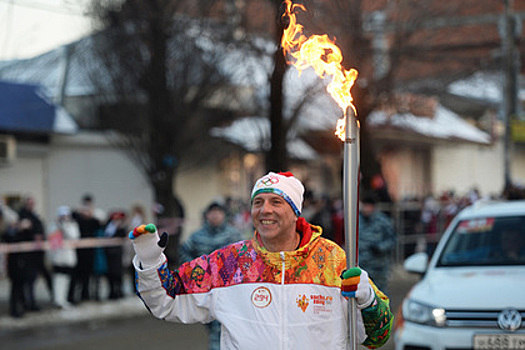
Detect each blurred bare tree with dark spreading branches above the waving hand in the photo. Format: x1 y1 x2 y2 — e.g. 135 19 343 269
87 0 239 217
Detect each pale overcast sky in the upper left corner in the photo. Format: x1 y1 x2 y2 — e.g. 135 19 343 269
0 0 91 60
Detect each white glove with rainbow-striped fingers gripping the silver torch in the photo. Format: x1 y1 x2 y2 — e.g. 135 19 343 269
341 267 376 309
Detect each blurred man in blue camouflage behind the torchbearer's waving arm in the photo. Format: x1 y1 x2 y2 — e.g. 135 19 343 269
179 202 242 350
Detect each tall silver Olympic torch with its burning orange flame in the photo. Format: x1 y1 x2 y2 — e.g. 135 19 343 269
281 0 359 350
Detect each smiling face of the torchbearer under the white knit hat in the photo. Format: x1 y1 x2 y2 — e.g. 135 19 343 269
251 193 297 243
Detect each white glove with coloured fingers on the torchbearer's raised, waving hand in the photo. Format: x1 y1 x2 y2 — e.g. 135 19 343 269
129 224 168 269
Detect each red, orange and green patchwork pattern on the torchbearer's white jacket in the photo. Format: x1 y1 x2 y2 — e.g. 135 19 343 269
149 219 393 348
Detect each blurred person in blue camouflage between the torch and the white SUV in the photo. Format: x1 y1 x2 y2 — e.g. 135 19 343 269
359 193 396 292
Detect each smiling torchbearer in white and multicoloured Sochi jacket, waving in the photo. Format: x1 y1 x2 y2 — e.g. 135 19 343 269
130 173 393 350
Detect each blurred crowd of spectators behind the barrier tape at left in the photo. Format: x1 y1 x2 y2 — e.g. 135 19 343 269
0 194 145 318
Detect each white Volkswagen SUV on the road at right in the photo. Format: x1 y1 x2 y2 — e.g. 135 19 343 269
395 201 525 350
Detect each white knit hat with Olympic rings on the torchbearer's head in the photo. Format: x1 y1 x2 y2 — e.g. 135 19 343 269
252 171 304 216
